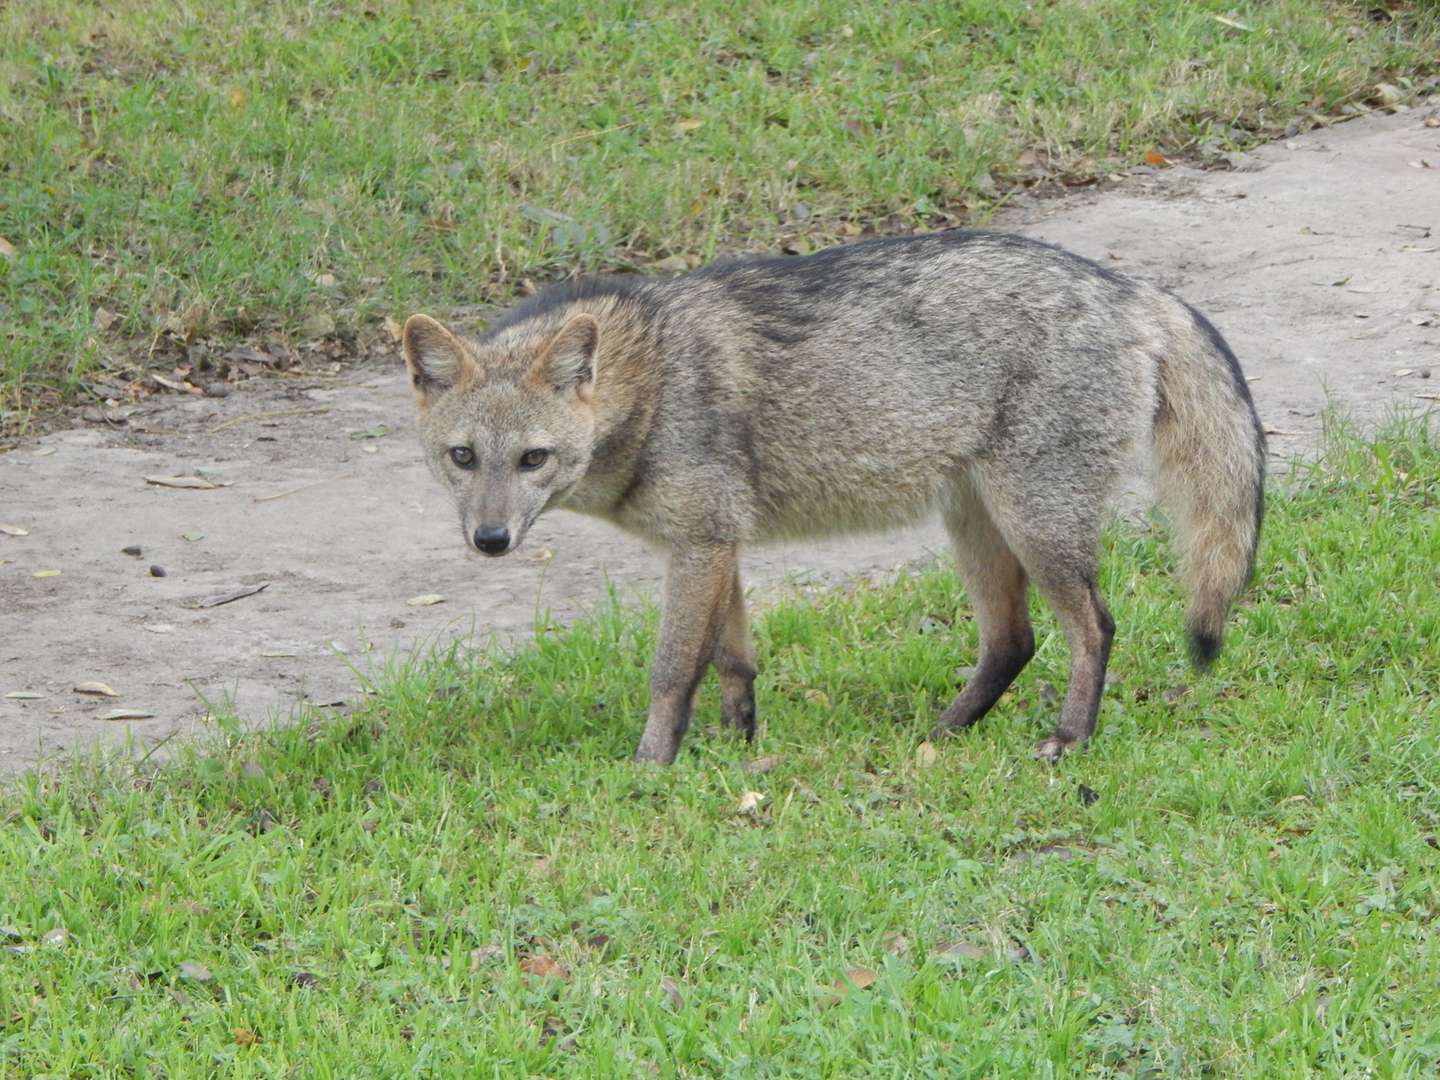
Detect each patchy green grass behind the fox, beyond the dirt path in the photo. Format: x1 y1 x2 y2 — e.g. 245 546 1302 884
0 0 1440 433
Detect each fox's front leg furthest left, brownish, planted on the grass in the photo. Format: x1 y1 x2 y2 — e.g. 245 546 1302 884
635 544 737 765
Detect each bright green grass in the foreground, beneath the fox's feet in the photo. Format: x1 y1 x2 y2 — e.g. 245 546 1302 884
0 423 1440 1080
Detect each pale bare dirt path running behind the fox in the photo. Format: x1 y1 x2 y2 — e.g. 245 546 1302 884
0 109 1440 769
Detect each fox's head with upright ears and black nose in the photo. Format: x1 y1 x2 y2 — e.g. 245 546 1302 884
402 314 600 556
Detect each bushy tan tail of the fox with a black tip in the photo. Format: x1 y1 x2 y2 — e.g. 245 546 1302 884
1155 310 1266 668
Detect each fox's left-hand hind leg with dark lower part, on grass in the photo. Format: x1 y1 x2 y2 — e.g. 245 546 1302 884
935 480 1035 737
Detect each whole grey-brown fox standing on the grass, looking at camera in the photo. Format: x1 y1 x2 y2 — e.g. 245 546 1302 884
405 232 1264 762
